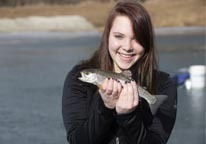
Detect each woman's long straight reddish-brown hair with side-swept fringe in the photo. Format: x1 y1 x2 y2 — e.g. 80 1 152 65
80 0 157 93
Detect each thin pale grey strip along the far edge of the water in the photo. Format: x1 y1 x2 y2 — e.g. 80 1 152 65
0 26 203 37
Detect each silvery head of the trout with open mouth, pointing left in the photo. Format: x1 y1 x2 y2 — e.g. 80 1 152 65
79 69 97 84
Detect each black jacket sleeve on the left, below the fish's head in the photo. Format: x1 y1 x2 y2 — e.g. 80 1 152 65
62 66 114 144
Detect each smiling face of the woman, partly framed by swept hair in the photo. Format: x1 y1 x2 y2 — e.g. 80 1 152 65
109 16 144 72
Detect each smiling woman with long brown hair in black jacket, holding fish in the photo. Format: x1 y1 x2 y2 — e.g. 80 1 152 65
62 0 177 144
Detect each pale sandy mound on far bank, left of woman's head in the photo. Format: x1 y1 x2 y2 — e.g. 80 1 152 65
0 15 95 32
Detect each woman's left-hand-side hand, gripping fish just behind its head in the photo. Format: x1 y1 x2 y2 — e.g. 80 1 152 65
99 78 122 109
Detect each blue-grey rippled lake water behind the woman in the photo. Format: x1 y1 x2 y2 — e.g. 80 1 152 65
0 32 205 144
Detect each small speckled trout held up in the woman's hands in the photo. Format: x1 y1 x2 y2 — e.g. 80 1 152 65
78 69 167 114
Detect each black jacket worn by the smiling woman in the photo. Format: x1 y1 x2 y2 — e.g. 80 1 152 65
62 66 177 144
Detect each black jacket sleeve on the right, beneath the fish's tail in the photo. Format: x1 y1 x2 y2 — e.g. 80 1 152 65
116 75 177 144
